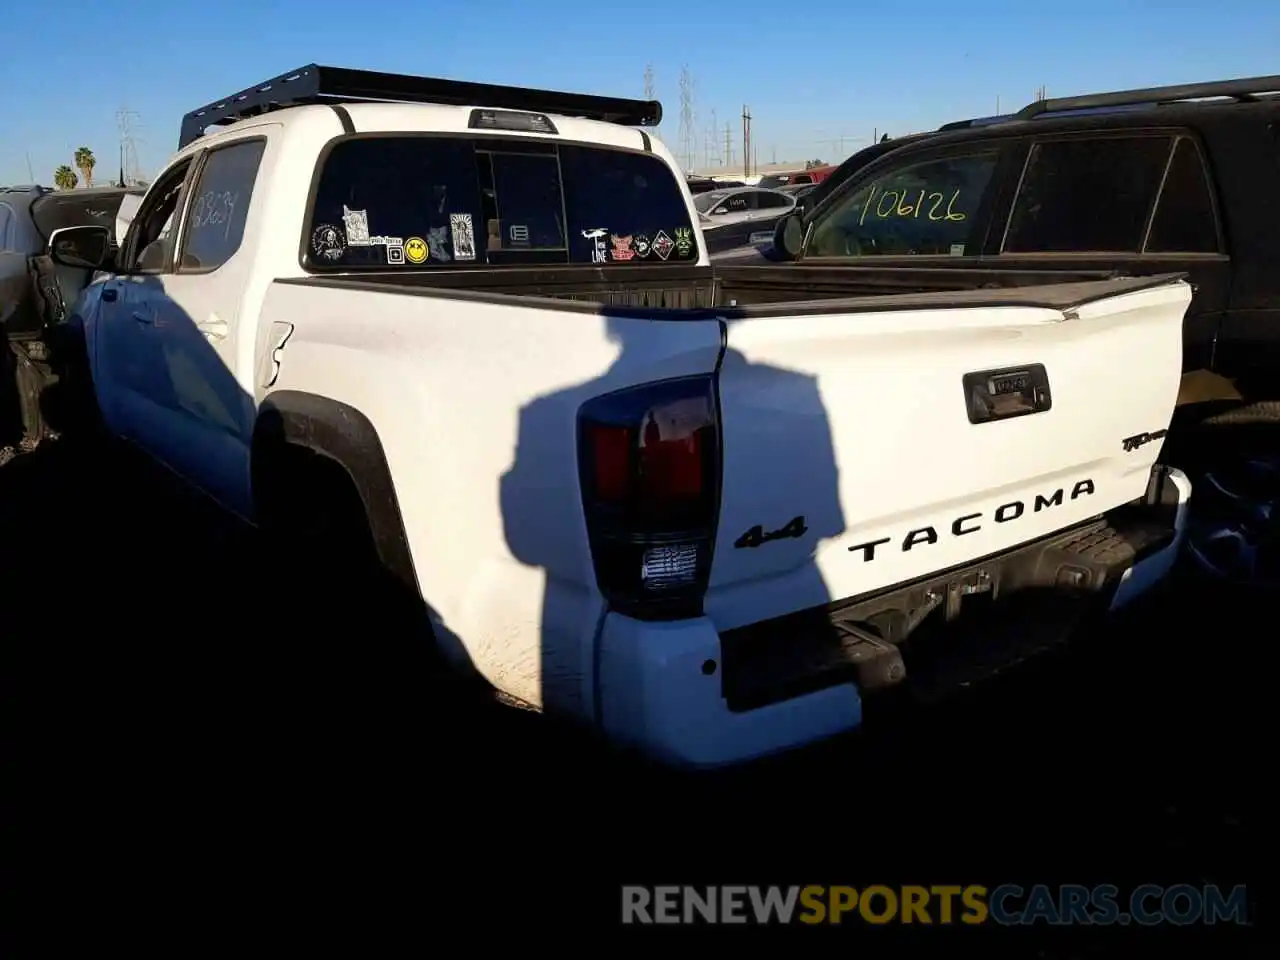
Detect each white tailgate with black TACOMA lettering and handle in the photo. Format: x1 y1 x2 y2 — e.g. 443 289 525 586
705 276 1192 630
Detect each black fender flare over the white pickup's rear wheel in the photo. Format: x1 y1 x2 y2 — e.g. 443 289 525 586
250 390 419 594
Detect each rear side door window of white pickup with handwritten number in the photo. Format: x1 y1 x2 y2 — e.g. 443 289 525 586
178 140 266 273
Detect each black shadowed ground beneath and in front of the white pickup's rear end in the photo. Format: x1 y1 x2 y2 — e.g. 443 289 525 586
0 442 1259 956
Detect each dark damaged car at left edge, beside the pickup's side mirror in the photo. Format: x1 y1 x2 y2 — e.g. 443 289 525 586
0 184 143 448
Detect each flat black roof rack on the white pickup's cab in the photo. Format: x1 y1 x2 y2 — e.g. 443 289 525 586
178 64 662 150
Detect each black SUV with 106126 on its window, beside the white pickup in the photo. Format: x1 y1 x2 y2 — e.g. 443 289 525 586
757 77 1280 401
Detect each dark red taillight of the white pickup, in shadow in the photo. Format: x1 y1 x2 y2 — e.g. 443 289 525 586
579 376 719 620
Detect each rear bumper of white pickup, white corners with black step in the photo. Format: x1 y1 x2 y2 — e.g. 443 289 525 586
596 467 1190 767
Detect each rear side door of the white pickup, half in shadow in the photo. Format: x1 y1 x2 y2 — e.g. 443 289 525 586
133 136 266 516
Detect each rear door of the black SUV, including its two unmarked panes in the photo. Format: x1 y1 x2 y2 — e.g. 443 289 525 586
998 129 1231 371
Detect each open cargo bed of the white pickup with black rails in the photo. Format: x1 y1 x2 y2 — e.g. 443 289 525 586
280 265 1162 320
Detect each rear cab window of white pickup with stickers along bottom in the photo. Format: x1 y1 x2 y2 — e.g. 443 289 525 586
305 137 699 270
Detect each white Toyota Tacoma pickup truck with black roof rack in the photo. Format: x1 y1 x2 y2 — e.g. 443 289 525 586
51 65 1190 765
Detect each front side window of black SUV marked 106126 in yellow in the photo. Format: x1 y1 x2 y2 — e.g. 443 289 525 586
805 150 998 257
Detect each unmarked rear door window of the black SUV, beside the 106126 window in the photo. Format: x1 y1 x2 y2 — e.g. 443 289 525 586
1004 137 1171 253
